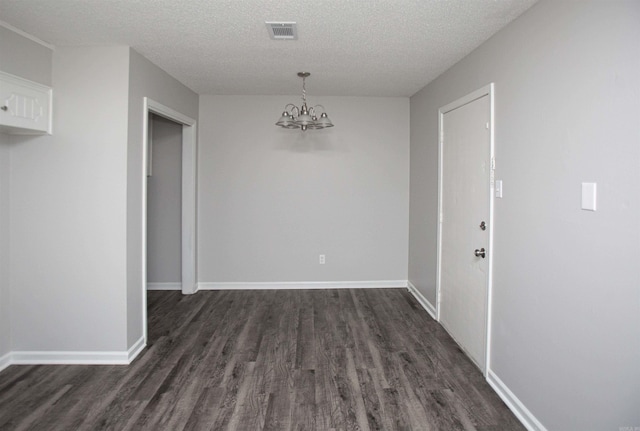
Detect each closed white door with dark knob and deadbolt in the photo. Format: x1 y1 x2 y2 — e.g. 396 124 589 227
439 93 492 371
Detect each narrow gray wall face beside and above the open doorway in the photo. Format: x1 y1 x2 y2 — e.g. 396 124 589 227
126 49 198 346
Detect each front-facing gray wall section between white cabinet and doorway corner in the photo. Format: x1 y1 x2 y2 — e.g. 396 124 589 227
10 47 129 351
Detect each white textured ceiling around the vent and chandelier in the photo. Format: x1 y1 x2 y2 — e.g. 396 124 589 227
0 0 536 96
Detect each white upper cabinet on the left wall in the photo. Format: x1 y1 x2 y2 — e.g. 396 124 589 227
0 71 52 135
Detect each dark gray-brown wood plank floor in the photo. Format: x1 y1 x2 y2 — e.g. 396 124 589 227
0 289 524 431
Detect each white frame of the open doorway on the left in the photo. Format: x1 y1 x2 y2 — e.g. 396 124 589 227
142 97 198 343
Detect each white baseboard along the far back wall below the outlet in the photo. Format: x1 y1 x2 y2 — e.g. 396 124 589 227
198 280 407 290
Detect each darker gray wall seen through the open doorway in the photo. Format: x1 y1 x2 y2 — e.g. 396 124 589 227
147 115 182 283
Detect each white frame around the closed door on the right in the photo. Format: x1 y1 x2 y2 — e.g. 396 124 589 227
436 83 495 377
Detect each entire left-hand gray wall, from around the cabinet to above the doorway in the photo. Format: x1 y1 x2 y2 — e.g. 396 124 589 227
0 27 198 355
